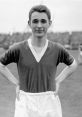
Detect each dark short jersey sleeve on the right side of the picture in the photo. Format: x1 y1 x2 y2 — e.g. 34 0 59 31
57 45 74 65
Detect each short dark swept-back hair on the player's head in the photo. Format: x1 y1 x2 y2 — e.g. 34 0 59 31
29 5 51 20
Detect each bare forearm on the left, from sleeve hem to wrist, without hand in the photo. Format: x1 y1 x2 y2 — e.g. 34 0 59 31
0 63 19 86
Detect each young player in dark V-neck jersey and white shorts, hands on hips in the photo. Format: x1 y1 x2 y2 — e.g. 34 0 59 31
0 5 77 117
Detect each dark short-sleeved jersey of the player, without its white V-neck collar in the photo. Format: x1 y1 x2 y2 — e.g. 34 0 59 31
0 40 74 93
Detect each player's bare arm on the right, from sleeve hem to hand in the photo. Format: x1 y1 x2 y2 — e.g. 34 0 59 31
56 59 77 92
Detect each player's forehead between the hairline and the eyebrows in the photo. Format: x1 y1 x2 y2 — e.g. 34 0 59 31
31 12 48 20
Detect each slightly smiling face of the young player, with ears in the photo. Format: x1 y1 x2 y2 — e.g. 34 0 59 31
29 12 51 37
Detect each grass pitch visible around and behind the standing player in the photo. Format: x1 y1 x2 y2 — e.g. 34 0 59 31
0 50 82 117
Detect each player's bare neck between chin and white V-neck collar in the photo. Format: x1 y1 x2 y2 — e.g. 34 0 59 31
31 35 47 47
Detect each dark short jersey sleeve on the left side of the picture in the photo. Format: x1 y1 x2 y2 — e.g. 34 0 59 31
0 44 20 65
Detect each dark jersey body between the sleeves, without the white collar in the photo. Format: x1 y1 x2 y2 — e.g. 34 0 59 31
18 39 58 92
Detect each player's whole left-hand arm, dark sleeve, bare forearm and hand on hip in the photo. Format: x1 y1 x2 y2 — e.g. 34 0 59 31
0 44 20 99
